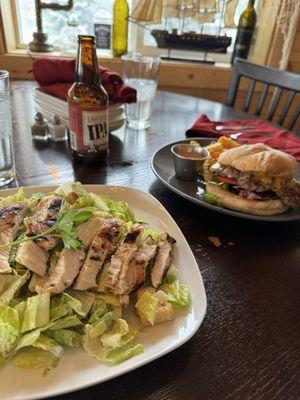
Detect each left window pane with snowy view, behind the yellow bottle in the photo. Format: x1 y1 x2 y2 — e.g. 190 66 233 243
15 0 132 52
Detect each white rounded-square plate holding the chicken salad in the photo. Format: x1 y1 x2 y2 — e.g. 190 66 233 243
0 185 206 400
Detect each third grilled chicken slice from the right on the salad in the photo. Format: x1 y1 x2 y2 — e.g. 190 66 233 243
106 224 144 294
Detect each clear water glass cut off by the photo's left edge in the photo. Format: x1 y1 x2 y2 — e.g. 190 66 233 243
0 70 15 186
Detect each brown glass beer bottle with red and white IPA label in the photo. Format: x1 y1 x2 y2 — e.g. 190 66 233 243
67 35 109 161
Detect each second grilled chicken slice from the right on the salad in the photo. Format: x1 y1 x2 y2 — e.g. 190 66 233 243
127 237 157 293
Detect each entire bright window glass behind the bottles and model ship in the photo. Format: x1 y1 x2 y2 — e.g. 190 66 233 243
14 0 254 62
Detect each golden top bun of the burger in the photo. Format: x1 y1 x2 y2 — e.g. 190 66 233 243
218 143 297 179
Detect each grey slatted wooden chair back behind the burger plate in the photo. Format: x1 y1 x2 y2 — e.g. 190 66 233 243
225 58 300 129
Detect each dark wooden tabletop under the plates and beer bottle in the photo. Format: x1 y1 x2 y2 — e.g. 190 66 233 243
7 82 300 400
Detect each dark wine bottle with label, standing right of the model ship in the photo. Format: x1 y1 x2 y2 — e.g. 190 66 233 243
231 0 256 64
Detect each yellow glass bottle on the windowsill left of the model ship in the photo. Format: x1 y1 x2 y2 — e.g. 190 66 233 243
113 0 129 57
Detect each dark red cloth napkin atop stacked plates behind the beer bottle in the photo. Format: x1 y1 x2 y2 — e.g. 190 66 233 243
30 57 136 103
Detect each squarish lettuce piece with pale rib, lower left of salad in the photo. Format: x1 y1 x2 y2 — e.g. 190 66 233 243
15 292 50 333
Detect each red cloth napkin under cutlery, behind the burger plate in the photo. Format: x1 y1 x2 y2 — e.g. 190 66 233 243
186 114 300 161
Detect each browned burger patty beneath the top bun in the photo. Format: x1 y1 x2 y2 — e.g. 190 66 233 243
219 167 300 208
